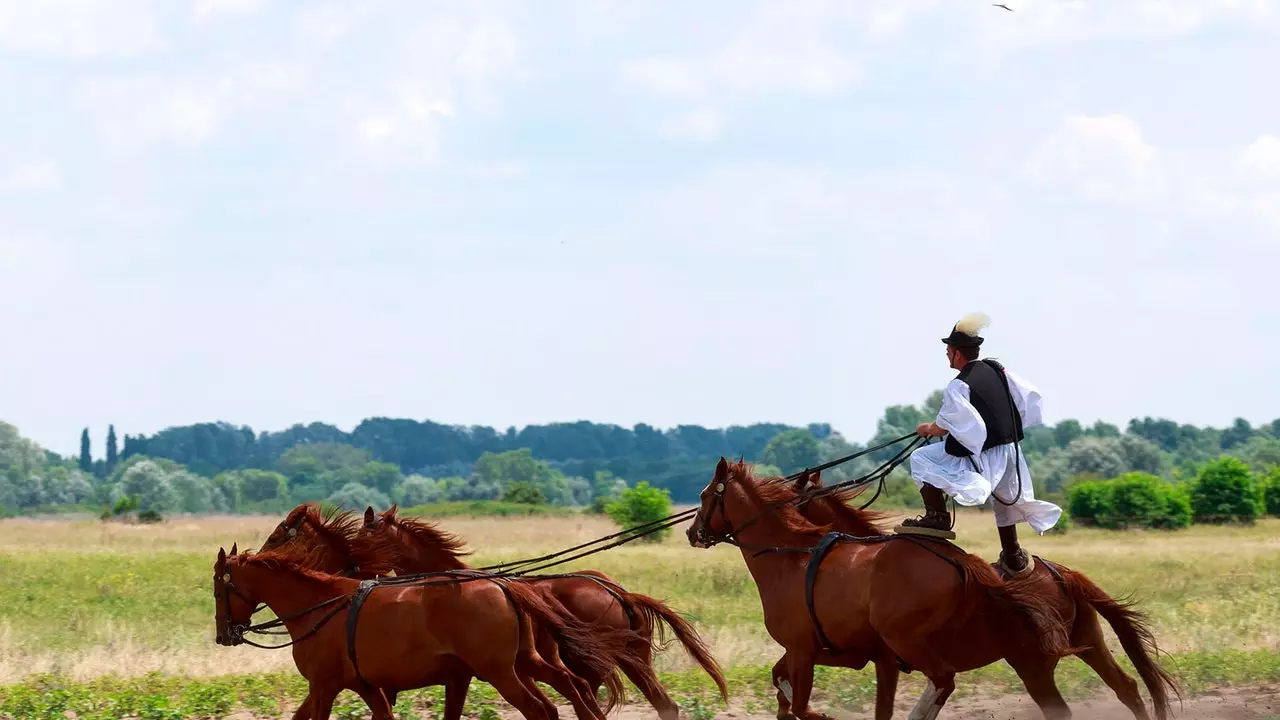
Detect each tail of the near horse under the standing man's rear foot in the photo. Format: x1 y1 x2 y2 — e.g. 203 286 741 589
956 553 1076 659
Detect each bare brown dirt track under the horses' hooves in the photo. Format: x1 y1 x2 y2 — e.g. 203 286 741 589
222 685 1280 720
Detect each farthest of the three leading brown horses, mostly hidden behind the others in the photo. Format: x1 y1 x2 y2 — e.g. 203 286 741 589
365 505 728 720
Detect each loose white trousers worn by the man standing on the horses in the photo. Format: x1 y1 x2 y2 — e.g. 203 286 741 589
911 442 1062 534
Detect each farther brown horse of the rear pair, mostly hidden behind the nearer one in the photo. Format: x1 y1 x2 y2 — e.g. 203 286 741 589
774 473 1180 720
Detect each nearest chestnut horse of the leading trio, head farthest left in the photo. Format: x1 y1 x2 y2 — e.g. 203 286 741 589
225 520 628 720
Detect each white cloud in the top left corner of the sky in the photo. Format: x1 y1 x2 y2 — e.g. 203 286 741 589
0 0 165 59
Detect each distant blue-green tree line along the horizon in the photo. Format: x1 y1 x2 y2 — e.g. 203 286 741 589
0 392 1280 514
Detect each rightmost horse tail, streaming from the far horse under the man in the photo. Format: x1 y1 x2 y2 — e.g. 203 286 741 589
1056 565 1183 720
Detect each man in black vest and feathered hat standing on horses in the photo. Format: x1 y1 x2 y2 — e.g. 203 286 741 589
897 314 1062 575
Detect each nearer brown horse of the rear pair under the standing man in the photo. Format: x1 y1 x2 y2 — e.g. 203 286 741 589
687 457 1073 720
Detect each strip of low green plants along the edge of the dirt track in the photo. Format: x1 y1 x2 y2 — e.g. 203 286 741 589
0 652 1280 720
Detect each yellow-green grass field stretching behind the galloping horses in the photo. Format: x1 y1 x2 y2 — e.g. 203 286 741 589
0 511 1280 717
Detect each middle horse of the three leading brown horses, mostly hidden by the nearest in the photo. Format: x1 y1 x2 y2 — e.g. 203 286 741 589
250 503 630 720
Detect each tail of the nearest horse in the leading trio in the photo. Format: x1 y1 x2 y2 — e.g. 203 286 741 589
503 573 637 715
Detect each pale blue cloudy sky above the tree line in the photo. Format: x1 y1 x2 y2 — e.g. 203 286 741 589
0 0 1280 452
